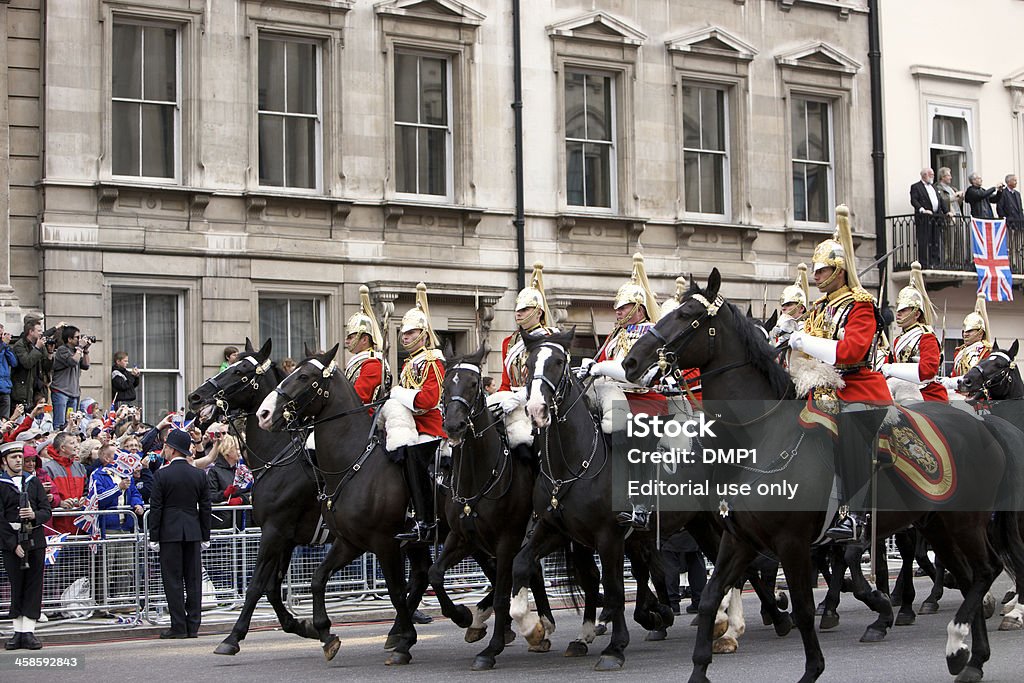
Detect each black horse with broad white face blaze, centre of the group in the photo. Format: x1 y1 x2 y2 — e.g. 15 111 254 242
511 332 673 671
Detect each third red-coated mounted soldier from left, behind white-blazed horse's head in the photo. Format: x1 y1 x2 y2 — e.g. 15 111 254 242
487 261 558 461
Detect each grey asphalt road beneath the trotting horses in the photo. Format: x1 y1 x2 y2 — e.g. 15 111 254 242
0 577 1024 683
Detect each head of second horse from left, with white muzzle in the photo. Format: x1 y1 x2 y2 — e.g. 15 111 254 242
256 344 339 431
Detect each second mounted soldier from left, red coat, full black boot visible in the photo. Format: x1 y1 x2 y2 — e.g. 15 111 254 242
381 283 446 543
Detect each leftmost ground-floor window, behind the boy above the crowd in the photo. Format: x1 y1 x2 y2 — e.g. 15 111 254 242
111 289 184 421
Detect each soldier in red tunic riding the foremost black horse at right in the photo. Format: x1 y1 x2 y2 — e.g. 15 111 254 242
790 206 892 541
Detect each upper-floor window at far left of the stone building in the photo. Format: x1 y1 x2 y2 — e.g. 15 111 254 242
111 23 181 178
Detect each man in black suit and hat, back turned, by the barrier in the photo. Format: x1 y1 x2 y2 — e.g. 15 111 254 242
150 429 210 638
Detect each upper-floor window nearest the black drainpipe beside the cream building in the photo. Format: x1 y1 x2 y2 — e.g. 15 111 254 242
793 97 834 223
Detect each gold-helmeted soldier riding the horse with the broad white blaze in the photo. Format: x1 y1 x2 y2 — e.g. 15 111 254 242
580 254 669 528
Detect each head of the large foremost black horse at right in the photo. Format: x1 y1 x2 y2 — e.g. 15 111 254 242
623 268 724 386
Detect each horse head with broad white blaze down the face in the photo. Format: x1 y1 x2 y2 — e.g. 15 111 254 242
523 328 575 429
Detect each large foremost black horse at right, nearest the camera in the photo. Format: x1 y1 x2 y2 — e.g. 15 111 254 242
623 269 1020 682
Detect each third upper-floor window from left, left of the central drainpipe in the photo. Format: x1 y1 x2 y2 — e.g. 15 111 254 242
394 52 452 197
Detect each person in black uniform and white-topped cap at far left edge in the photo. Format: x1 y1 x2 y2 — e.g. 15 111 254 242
0 441 50 650
